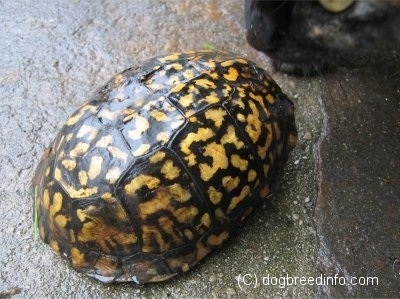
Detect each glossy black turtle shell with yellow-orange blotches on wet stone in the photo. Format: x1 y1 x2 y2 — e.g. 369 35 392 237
32 51 297 283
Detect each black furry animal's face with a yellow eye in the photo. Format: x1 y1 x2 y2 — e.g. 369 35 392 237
245 0 400 74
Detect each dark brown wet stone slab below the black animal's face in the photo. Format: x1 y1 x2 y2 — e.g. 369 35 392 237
315 55 400 297
